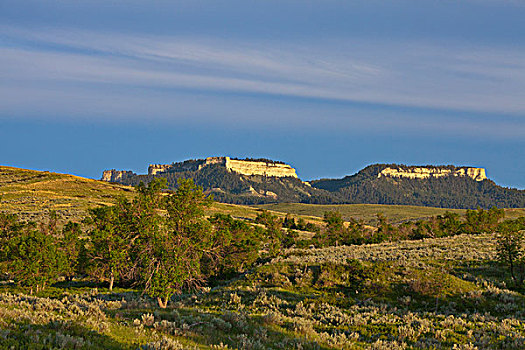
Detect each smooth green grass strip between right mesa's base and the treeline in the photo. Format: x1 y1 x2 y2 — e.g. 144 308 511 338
255 203 525 223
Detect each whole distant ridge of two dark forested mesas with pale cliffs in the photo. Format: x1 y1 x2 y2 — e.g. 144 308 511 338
102 157 525 209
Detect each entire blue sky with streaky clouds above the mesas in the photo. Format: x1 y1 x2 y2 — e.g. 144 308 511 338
0 0 525 189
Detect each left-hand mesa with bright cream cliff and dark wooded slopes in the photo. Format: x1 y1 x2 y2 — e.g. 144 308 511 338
102 157 330 204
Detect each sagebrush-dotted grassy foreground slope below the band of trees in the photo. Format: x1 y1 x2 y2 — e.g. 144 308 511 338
0 234 525 350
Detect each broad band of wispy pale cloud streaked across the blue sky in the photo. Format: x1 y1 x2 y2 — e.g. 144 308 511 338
0 26 525 134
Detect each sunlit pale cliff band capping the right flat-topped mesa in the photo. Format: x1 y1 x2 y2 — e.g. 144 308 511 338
377 166 487 181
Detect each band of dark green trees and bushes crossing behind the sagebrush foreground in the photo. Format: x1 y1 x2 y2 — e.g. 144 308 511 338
0 186 525 307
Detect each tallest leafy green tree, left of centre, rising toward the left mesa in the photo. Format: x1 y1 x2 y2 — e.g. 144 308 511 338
141 179 212 308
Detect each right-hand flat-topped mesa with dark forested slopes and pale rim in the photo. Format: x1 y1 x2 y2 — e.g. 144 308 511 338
311 164 525 209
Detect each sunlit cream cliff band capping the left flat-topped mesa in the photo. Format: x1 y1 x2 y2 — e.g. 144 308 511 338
148 157 297 178
